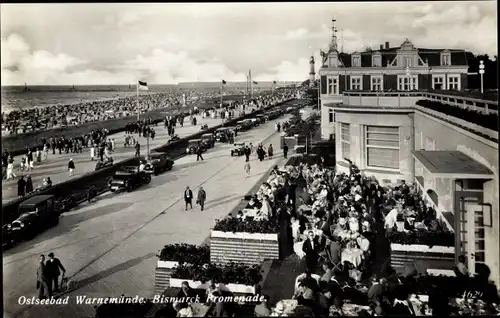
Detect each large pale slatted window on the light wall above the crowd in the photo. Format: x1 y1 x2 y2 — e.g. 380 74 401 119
365 126 399 169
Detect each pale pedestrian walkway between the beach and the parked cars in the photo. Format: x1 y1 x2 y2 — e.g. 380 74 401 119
2 116 221 204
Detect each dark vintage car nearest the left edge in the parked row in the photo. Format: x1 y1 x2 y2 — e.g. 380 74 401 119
10 195 61 241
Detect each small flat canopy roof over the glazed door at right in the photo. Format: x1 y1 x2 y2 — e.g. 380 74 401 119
413 150 493 179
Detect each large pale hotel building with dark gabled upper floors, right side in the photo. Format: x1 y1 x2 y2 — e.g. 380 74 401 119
319 19 500 286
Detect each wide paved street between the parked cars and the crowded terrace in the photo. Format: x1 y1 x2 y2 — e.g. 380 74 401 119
4 103 312 317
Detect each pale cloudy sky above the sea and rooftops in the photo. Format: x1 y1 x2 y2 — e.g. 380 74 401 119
0 1 497 85
